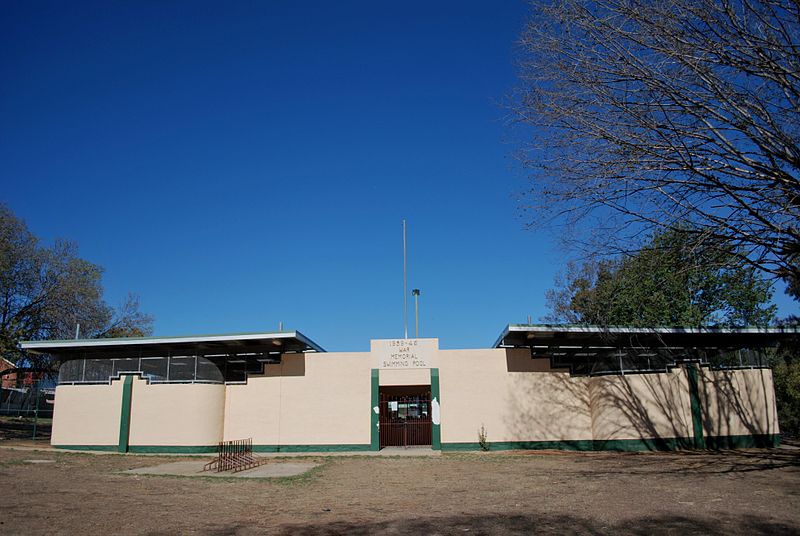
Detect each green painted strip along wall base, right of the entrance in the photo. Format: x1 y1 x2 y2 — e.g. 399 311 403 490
442 434 780 452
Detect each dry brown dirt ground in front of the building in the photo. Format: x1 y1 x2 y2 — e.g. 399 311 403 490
0 443 800 535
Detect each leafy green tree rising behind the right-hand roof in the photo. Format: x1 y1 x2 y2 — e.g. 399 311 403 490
546 227 775 327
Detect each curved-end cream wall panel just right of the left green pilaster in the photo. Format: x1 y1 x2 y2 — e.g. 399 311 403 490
128 377 225 446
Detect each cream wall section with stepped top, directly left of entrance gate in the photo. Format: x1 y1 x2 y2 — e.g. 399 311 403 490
225 353 371 445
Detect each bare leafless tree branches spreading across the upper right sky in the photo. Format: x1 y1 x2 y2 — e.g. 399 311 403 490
511 0 800 296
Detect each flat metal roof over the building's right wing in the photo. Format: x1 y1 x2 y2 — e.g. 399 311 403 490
494 324 800 348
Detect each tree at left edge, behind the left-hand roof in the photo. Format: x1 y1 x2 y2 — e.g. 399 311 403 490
0 205 153 374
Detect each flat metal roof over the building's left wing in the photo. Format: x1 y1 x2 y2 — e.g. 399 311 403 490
19 331 325 356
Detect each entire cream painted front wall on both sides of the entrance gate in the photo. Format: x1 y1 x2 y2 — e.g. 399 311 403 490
52 349 778 446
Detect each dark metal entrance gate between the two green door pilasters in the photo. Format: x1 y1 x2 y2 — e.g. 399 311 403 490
379 393 432 448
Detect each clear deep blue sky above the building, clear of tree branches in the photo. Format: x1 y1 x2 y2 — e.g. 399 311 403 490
0 0 795 350
